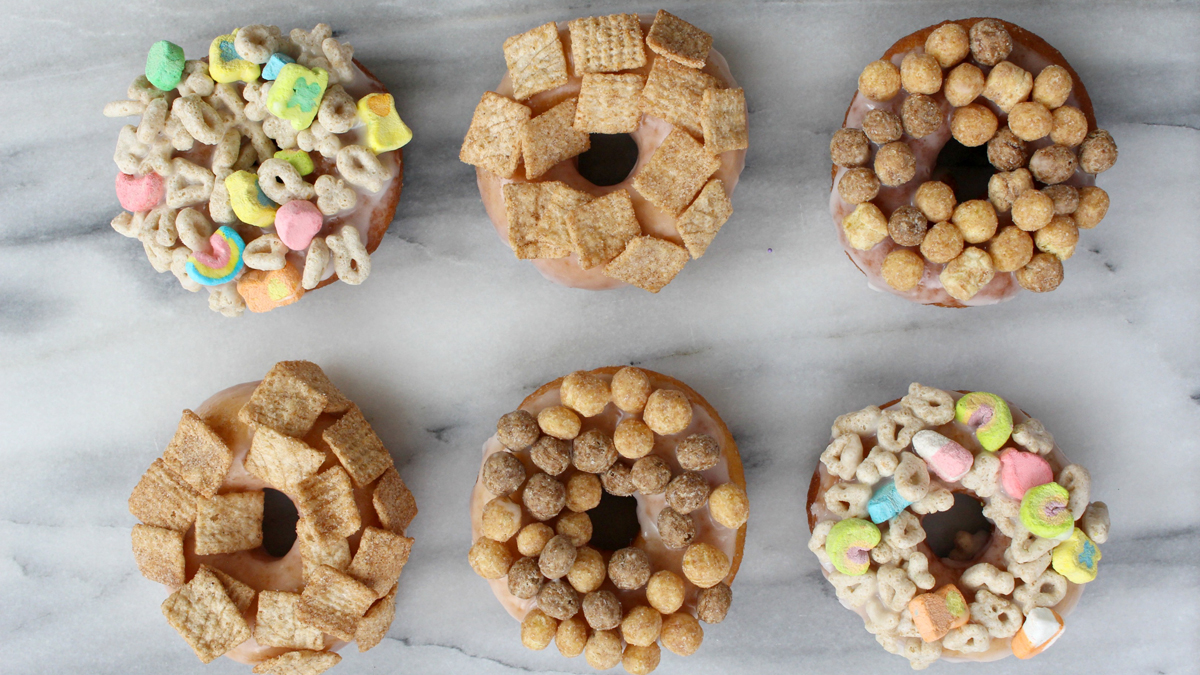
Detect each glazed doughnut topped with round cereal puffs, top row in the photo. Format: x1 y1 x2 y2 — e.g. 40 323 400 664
829 18 1117 307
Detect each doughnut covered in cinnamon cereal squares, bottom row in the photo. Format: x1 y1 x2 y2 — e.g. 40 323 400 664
130 362 416 674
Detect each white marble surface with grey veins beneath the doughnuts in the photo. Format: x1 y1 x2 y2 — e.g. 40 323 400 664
0 0 1200 675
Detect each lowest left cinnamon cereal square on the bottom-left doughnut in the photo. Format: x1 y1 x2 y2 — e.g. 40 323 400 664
162 562 250 663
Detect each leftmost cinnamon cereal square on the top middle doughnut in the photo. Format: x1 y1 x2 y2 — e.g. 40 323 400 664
458 91 533 178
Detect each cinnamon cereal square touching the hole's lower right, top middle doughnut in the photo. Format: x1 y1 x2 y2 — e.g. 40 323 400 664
632 129 721 215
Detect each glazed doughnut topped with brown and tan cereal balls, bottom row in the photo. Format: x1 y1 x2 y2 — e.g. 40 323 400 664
468 368 750 674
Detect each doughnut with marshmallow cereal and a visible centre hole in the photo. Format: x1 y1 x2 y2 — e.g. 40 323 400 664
806 383 1109 669
